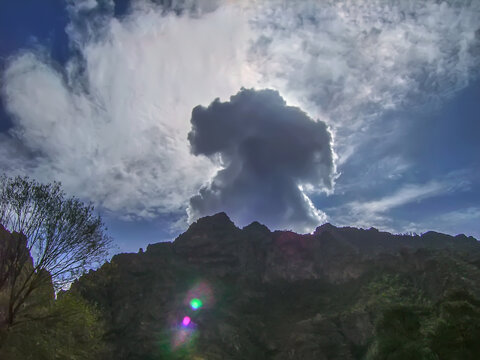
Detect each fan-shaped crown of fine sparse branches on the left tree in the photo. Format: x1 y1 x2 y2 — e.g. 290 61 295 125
0 176 111 290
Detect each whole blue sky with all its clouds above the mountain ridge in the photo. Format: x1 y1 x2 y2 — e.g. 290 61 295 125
0 0 480 252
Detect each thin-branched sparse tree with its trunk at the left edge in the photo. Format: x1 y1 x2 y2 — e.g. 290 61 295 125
0 176 111 327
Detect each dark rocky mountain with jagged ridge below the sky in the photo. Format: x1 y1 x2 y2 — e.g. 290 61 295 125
70 213 480 360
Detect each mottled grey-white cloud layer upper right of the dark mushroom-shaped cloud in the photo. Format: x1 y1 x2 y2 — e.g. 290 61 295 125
251 0 480 163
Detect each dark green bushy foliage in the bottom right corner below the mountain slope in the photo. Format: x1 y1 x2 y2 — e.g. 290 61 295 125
367 290 480 360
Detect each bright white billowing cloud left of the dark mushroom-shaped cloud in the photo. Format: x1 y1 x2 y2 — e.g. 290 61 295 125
0 2 258 218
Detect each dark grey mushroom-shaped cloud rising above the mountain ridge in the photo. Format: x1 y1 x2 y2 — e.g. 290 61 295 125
188 89 335 230
